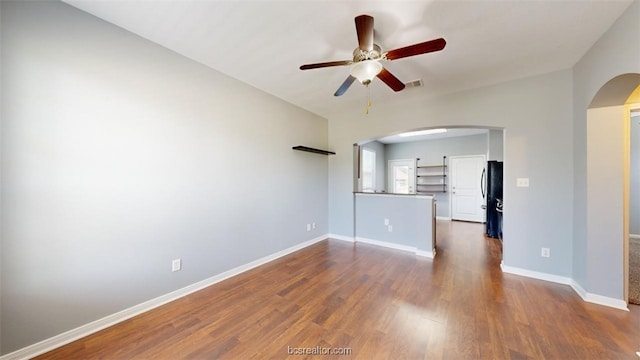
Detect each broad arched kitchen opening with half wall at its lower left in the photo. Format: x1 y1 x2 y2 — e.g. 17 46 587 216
353 126 506 257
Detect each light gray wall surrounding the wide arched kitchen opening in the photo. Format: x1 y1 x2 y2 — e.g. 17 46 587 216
329 70 573 282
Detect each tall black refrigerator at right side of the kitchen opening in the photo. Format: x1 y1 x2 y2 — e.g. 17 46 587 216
481 161 502 238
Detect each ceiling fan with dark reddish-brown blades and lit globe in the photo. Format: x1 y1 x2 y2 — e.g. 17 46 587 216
300 15 447 96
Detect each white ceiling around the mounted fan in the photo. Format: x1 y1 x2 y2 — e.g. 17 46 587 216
65 0 632 117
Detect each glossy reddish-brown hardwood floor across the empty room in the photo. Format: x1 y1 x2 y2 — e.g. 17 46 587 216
38 221 640 359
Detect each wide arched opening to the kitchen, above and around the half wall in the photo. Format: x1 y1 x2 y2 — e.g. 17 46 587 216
354 128 505 256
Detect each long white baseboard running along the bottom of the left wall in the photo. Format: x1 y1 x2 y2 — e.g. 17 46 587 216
0 235 329 360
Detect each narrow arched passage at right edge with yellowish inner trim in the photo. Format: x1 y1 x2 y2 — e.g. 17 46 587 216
586 74 640 307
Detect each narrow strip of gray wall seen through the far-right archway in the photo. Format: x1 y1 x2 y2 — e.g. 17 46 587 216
629 112 640 236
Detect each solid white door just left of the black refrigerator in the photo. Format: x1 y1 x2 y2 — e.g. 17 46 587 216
449 155 486 222
